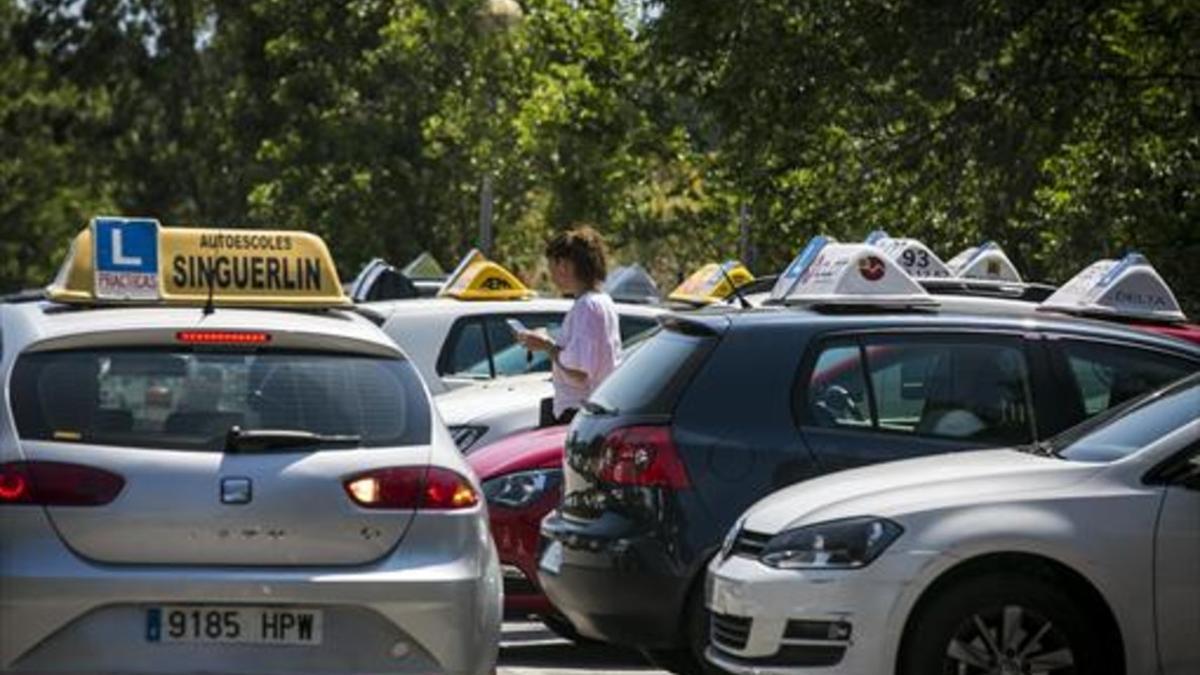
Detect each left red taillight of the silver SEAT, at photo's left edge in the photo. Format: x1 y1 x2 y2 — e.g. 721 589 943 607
0 461 125 506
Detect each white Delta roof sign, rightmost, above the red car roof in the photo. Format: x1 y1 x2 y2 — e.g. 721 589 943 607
1042 253 1187 323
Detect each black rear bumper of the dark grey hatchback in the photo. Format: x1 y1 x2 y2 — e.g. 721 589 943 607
538 513 692 649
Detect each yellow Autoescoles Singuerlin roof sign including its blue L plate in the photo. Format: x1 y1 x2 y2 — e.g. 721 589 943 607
47 217 350 307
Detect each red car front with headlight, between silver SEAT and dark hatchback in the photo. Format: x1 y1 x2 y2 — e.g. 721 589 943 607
467 426 578 640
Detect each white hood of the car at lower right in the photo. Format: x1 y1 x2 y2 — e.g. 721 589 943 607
743 449 1104 534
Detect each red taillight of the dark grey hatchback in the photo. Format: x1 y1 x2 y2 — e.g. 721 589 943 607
598 426 691 490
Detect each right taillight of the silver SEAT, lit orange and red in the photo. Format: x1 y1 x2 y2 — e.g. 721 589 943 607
343 466 479 510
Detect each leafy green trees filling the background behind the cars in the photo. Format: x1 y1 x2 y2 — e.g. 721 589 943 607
0 0 1200 315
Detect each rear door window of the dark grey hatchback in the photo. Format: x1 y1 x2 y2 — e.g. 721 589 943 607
865 338 1033 444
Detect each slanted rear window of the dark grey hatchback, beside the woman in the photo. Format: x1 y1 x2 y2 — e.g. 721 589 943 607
589 330 716 414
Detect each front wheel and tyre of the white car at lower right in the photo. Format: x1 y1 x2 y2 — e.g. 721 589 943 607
899 573 1121 675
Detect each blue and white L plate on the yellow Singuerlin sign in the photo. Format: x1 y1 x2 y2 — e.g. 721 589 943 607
91 217 158 299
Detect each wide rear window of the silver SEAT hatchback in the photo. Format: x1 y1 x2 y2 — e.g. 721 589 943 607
11 350 431 452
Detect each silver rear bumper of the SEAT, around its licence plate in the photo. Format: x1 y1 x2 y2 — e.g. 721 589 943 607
0 509 500 674
